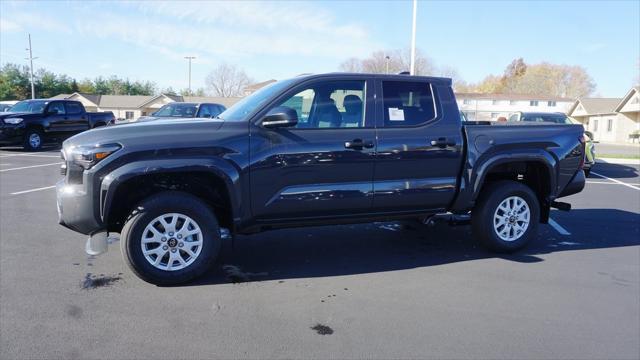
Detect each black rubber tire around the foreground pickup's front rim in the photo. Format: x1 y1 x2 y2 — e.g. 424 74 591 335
120 191 221 285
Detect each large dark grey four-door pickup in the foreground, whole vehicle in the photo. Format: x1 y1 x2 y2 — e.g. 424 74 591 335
57 73 585 284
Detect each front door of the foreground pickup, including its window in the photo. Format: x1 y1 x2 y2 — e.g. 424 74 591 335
250 77 375 219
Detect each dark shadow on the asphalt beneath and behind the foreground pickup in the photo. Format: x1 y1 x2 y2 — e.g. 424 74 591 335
186 209 640 286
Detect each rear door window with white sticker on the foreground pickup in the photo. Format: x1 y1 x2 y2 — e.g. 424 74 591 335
382 81 436 127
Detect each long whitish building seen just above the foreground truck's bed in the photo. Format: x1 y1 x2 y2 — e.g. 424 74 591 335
456 93 575 121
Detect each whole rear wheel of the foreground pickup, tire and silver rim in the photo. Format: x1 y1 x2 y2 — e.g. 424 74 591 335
471 181 540 252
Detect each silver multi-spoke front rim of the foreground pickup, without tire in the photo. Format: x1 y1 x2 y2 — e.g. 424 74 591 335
140 213 202 271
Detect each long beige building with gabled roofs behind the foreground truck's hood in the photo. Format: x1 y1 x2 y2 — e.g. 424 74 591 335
53 93 240 120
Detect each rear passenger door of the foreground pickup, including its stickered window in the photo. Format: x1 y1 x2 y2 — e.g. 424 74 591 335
373 78 463 212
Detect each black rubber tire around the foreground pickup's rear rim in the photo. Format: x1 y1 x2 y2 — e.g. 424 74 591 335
471 180 540 253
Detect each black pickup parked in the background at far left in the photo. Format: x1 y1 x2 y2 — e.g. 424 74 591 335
0 99 115 151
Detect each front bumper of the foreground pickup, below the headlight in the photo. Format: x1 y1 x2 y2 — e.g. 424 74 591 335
56 179 105 235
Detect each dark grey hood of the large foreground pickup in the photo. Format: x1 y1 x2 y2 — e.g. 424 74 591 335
63 119 229 149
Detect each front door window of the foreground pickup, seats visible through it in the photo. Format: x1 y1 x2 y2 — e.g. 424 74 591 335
276 81 365 129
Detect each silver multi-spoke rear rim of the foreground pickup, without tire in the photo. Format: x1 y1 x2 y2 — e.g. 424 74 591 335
493 196 531 241
